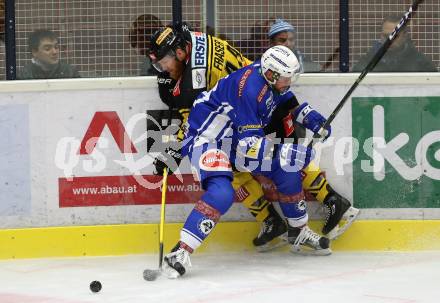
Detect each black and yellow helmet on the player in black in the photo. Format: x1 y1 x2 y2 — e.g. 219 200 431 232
150 26 186 62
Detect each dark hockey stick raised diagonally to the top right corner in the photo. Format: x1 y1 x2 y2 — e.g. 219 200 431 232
307 0 424 148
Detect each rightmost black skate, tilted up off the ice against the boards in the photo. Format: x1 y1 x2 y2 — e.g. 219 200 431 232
322 192 359 240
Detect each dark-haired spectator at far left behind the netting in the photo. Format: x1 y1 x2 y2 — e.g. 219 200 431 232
17 29 80 80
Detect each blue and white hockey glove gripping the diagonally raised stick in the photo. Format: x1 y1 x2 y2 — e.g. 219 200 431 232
294 102 332 141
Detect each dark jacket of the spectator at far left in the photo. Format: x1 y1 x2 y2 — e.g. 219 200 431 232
17 61 80 80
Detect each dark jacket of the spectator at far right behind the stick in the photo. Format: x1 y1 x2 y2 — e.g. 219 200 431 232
352 39 437 72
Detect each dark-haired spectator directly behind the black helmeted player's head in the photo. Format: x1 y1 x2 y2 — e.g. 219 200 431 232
128 14 163 76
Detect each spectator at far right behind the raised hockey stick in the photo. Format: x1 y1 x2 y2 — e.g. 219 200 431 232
352 16 437 72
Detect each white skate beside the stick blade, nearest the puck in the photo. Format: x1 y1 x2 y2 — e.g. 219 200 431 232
163 243 191 279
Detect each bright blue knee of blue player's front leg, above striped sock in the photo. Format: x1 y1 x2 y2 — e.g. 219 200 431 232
201 176 235 215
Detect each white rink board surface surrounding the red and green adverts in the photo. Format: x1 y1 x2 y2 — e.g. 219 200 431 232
0 75 440 228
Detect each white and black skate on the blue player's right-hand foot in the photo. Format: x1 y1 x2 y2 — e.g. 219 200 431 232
288 225 332 256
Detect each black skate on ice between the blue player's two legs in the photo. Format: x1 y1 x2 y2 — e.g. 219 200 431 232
253 210 288 252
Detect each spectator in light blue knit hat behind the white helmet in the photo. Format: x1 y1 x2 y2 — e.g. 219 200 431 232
268 19 321 73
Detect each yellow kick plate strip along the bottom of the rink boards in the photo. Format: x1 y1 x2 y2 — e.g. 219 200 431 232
0 220 440 259
